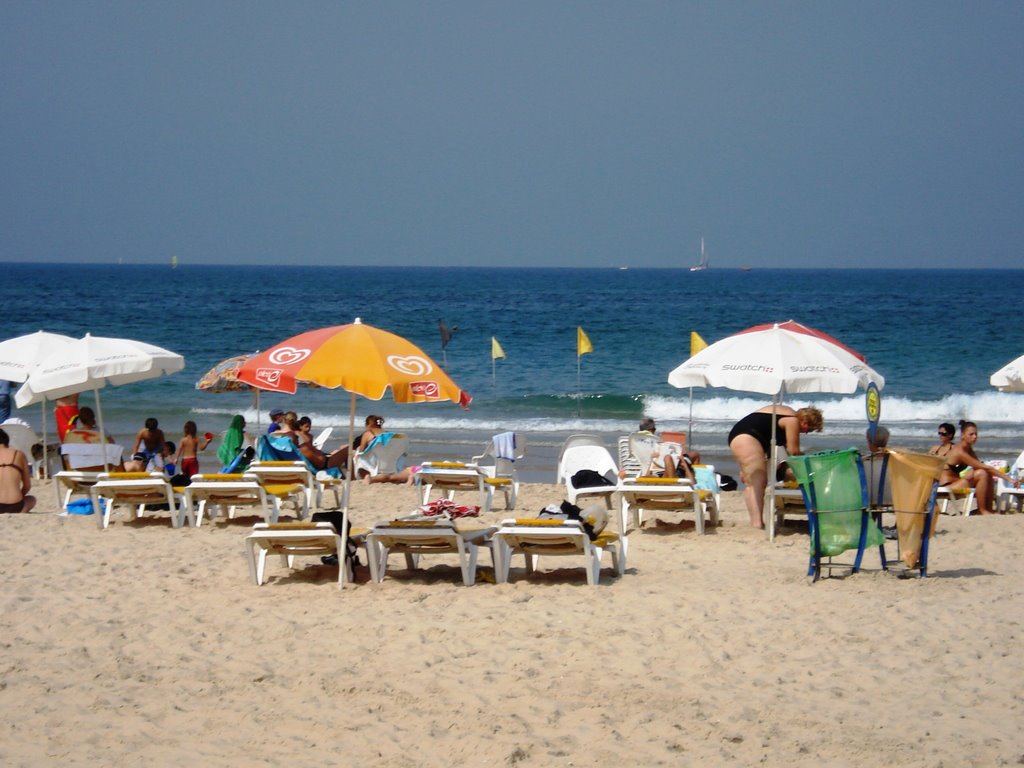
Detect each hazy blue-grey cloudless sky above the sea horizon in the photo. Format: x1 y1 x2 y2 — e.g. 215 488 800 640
0 0 1024 267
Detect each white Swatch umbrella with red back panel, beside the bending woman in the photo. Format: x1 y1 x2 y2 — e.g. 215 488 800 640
669 321 886 539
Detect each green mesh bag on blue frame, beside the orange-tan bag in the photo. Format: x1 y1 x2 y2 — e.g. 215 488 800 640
788 449 886 581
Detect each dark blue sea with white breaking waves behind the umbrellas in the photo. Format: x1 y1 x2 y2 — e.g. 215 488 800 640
0 259 1024 482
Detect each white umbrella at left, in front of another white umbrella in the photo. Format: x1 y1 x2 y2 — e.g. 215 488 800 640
14 334 185 468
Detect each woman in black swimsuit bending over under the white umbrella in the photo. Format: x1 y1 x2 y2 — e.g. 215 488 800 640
729 406 824 528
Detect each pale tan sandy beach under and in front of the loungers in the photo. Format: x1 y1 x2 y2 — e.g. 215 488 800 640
0 482 1024 766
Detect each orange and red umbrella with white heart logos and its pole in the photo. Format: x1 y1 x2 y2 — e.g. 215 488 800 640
238 317 472 589
